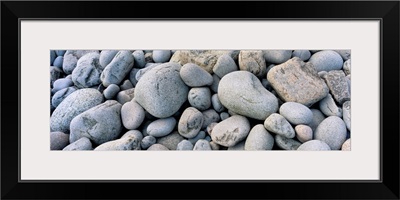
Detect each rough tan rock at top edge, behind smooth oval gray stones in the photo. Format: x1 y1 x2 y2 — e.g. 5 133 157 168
170 50 239 74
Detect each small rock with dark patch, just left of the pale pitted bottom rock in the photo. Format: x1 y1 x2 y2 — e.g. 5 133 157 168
178 107 204 138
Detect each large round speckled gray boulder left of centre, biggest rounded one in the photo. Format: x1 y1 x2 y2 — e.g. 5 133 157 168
135 62 189 118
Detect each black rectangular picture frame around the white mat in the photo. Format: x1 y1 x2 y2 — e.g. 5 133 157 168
1 1 400 199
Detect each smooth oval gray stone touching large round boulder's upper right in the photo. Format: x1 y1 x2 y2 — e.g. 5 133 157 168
179 63 213 87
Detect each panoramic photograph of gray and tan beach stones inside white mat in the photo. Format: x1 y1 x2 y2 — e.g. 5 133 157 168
49 49 351 151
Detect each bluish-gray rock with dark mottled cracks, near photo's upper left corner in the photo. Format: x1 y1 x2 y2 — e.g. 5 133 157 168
72 52 104 88
